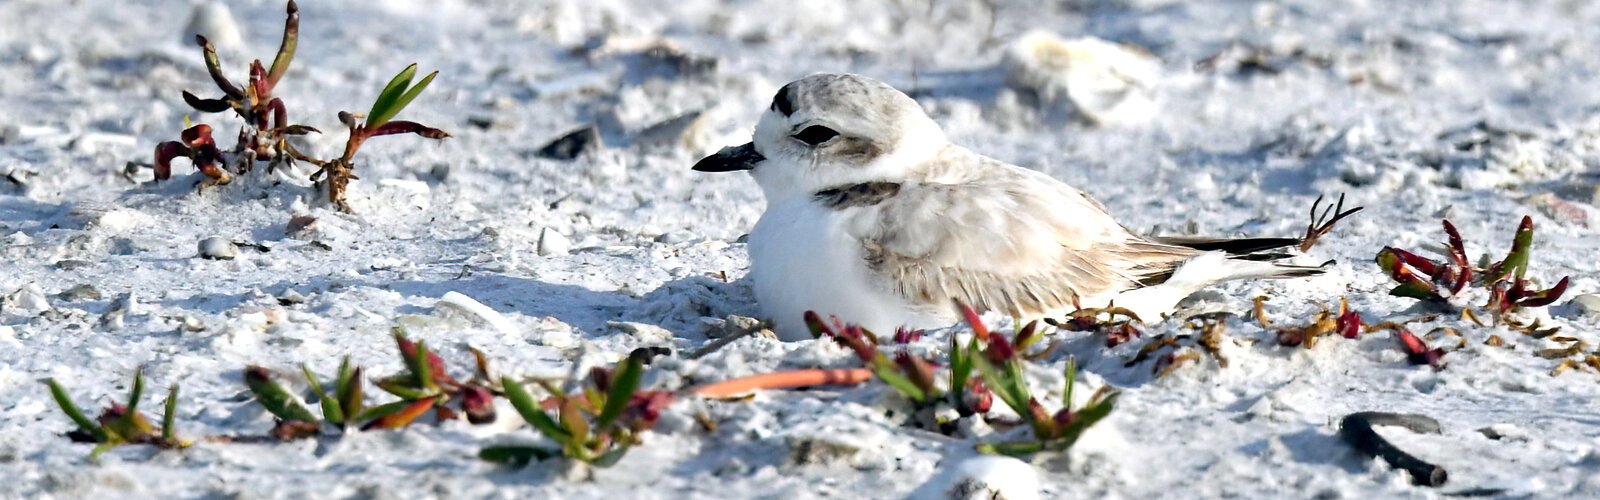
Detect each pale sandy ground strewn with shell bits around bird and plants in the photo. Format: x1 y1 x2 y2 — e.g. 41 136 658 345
0 0 1600 498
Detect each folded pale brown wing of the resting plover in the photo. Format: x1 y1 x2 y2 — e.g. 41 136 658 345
842 146 1200 316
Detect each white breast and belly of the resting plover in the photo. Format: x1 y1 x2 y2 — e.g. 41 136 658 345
749 199 950 340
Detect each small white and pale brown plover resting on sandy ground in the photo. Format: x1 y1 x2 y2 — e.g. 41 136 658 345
694 74 1320 340
